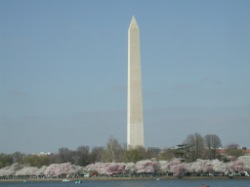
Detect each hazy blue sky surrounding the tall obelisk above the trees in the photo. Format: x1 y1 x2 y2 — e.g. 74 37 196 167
0 0 250 153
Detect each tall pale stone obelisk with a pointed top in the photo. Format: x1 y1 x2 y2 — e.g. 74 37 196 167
127 16 144 148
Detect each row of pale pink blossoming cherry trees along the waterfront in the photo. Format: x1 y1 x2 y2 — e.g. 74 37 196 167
0 156 250 177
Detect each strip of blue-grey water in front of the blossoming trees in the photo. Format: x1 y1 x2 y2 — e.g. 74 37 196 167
0 179 250 187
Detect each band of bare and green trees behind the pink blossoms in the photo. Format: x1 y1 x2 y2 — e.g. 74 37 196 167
0 133 244 168
